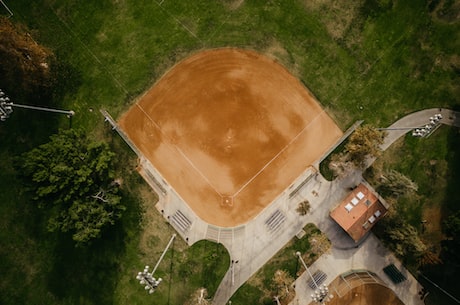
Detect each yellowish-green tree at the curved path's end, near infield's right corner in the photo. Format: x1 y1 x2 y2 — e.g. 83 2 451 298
345 125 386 169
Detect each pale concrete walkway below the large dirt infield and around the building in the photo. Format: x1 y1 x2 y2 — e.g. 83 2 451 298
155 109 460 305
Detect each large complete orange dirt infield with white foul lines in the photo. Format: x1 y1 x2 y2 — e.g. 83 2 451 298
119 48 342 227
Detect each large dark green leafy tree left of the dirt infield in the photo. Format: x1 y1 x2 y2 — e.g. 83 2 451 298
20 129 125 245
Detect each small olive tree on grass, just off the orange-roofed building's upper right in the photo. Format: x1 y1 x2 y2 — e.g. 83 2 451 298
378 170 418 198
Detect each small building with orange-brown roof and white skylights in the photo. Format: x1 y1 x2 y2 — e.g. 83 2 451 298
330 183 388 243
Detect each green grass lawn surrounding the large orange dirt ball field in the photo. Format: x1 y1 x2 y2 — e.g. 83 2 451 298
0 0 460 304
